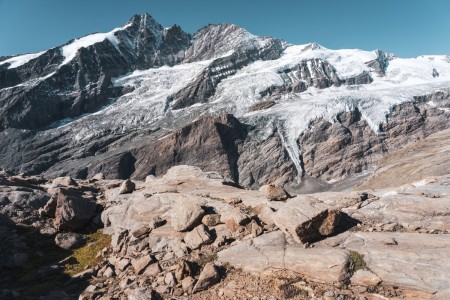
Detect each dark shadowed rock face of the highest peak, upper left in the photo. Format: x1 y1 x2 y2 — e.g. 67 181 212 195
0 14 191 129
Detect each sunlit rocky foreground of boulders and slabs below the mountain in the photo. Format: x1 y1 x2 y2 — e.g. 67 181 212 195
0 130 450 299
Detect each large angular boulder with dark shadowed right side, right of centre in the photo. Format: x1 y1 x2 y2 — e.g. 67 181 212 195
273 197 340 243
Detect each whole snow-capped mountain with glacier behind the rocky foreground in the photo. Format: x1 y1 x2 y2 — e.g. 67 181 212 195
0 14 450 188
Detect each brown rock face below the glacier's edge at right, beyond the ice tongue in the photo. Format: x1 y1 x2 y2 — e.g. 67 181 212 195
298 102 450 180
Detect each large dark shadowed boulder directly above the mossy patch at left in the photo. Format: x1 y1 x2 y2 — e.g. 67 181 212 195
54 188 96 230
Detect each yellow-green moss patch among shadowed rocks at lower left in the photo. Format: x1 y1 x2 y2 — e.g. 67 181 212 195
64 230 111 276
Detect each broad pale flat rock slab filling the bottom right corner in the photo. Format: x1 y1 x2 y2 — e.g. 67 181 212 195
342 232 450 294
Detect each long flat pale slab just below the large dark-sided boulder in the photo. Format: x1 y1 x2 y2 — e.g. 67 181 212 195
218 231 349 284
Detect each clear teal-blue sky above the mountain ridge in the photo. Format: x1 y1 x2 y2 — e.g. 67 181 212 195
0 0 450 57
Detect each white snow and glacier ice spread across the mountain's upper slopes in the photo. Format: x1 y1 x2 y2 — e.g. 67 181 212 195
35 39 450 173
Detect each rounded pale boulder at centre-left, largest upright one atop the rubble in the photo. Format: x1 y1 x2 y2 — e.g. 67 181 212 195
171 197 205 231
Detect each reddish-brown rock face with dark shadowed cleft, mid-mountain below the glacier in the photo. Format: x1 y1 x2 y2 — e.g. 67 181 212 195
133 115 248 182
